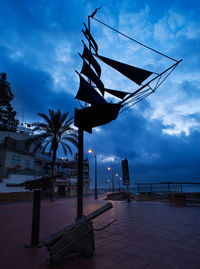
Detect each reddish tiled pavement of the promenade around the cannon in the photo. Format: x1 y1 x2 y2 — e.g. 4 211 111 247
0 197 200 269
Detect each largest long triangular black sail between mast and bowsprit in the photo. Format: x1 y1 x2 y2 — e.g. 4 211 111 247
95 54 153 85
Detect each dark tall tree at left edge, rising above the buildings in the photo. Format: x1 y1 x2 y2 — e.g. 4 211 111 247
0 73 18 132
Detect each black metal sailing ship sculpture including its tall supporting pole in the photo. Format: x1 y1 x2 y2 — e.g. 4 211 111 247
74 9 182 218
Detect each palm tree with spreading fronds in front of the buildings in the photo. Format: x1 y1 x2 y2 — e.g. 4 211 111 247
33 109 78 201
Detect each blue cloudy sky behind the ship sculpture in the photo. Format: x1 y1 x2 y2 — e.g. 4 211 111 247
0 0 200 185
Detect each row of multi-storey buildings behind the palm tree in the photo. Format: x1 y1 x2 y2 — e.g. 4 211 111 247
0 131 90 192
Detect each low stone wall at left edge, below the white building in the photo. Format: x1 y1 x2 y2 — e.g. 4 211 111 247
0 192 33 203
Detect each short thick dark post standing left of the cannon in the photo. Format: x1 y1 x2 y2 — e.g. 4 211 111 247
31 190 41 246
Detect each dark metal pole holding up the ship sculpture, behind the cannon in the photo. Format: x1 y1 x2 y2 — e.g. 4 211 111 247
77 128 84 220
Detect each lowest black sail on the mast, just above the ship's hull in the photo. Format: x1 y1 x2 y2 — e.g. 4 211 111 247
75 72 107 105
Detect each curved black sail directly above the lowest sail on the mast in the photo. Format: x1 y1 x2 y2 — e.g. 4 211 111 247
81 59 104 95
